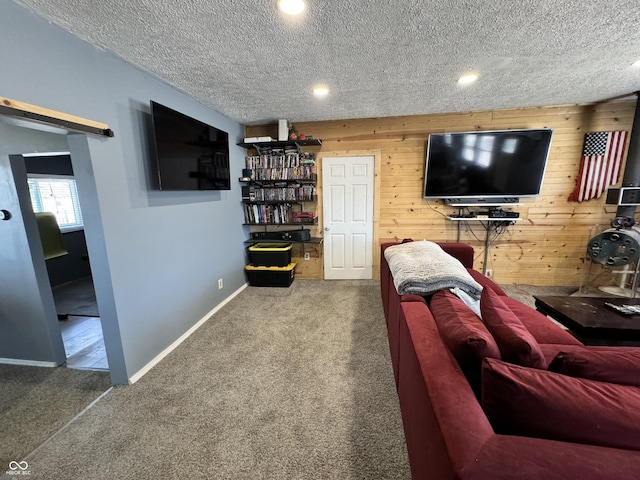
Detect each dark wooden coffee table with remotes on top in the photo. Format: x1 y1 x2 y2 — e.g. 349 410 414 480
533 296 640 345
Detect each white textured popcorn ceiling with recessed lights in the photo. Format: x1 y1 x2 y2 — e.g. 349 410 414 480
14 0 640 124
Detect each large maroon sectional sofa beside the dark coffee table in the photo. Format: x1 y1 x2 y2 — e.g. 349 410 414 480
380 242 640 480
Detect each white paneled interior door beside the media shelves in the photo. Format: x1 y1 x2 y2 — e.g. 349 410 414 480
322 156 375 280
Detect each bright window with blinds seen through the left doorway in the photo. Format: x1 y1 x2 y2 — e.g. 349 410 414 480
27 175 83 231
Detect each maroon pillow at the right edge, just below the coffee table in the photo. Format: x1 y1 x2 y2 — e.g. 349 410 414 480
549 347 640 388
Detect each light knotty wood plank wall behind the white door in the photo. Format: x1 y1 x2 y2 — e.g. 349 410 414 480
246 97 636 286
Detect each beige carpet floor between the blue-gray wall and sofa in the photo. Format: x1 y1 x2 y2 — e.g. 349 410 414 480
21 280 410 480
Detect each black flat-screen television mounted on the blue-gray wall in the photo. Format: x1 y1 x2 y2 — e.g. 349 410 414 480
151 100 231 190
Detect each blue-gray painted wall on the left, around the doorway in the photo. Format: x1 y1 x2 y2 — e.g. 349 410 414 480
0 2 246 383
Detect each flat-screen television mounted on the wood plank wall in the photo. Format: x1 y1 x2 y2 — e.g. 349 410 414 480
423 128 553 205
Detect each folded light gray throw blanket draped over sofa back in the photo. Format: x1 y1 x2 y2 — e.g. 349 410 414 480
384 240 482 299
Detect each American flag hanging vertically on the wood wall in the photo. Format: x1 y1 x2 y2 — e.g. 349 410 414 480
569 131 629 202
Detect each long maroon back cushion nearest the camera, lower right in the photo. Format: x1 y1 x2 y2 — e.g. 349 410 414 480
482 359 640 450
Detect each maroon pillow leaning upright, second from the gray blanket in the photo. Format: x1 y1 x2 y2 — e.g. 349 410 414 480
480 288 547 369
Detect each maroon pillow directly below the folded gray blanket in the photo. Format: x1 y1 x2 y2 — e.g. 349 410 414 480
429 290 500 371
